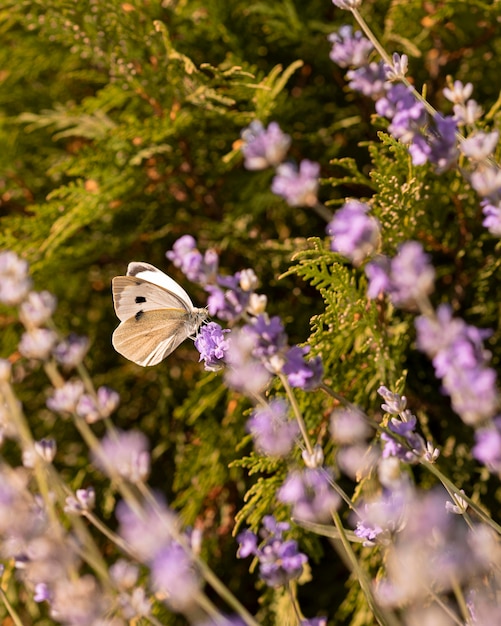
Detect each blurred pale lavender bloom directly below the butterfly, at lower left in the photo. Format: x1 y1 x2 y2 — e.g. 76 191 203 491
93 431 150 483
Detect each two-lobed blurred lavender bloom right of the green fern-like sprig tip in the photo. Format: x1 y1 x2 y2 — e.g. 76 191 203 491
365 241 435 306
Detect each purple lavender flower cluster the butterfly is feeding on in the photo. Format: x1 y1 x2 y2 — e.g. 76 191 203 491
167 237 323 395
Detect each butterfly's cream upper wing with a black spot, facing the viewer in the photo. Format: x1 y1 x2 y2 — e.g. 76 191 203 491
112 276 191 322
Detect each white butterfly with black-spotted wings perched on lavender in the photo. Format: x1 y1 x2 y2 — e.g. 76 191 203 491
112 263 208 367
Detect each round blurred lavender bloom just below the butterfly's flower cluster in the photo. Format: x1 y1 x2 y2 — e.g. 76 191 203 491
247 398 299 457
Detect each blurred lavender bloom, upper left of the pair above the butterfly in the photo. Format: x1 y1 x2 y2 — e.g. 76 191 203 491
242 120 291 170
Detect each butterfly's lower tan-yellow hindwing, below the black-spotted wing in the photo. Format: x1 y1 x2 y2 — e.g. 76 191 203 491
112 308 191 367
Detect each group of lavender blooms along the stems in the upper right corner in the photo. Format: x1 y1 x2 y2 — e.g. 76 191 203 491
329 26 501 237
